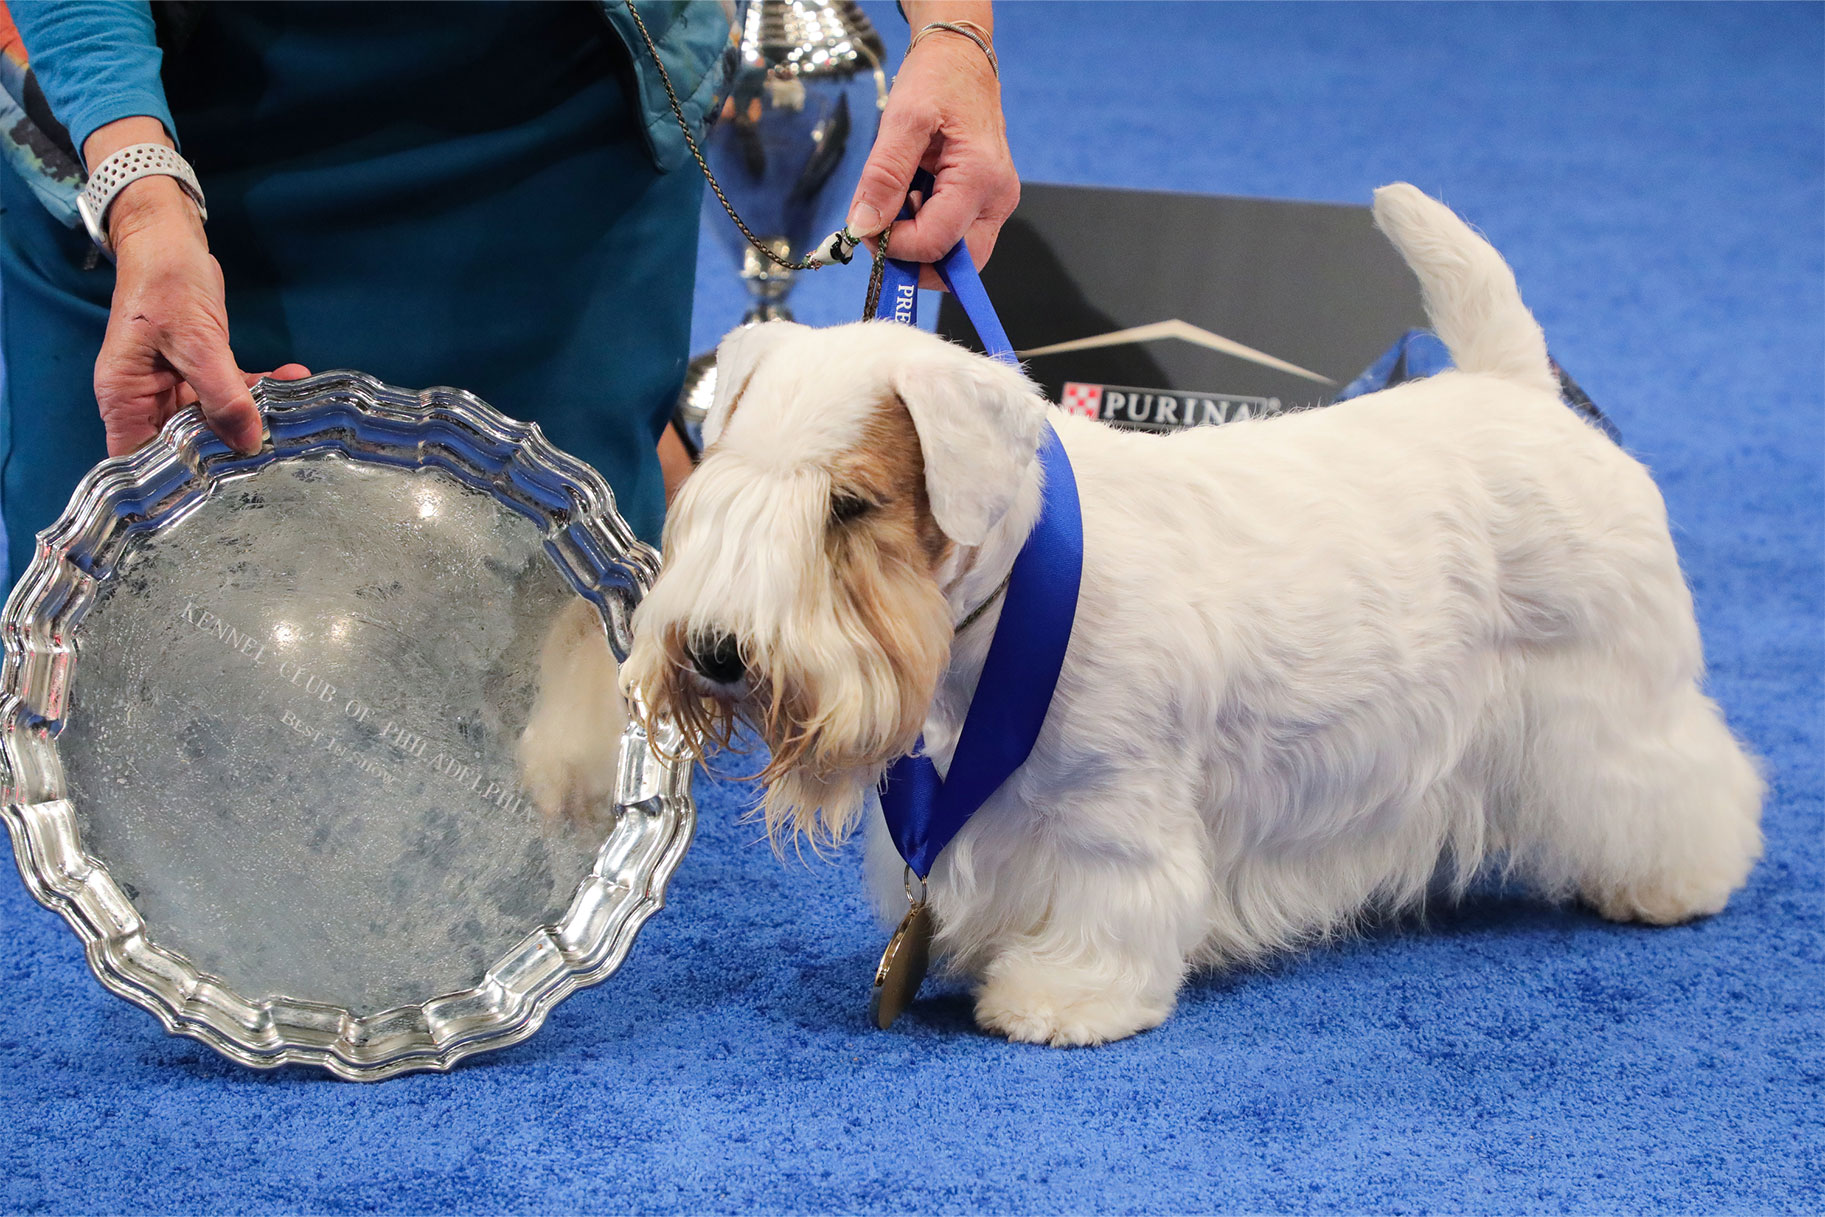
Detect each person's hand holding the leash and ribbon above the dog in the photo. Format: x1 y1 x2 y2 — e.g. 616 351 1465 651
849 4 1020 288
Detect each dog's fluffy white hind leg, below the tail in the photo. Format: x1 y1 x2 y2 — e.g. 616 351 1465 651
1515 655 1763 925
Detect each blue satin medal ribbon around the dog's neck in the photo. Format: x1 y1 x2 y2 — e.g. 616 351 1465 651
876 175 1084 879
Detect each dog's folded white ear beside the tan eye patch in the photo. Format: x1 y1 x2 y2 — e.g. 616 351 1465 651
894 348 1046 546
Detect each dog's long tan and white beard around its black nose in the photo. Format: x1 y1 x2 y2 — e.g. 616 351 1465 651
626 538 951 850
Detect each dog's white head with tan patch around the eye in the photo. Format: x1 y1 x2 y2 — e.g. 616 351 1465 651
622 321 1046 841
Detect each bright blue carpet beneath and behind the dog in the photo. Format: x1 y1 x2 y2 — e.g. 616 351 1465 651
0 4 1825 1213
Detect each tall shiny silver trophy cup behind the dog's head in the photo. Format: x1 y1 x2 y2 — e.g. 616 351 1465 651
679 0 887 447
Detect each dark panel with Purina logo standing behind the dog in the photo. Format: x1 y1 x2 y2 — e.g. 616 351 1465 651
938 182 1425 407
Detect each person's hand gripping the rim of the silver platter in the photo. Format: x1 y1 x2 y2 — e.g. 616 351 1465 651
84 119 310 456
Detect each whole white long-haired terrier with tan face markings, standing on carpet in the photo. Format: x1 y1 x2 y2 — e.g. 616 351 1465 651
622 186 1763 1045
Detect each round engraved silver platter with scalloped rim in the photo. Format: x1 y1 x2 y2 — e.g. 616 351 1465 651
0 372 695 1080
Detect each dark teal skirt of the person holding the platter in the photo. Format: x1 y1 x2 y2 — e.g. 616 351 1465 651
0 4 703 577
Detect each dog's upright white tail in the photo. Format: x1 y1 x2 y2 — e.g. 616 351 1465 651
1374 182 1559 394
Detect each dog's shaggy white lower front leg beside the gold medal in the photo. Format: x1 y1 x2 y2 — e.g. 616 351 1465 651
976 850 1208 1047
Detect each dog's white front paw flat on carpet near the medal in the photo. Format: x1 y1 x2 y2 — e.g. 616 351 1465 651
976 965 1172 1047
